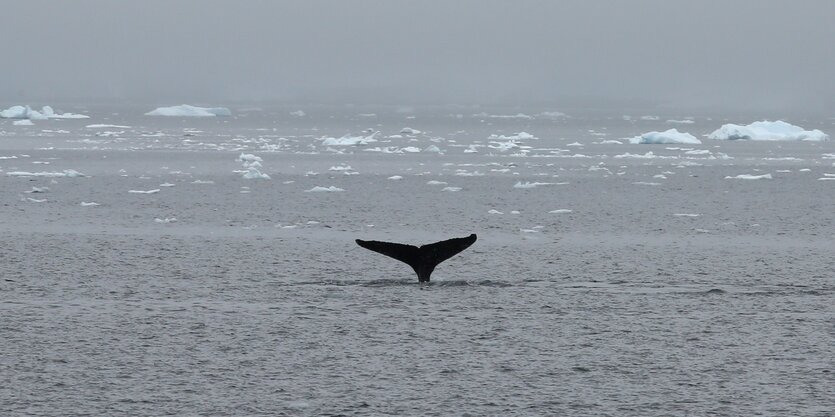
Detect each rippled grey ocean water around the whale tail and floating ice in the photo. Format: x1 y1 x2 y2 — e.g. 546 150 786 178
0 103 835 416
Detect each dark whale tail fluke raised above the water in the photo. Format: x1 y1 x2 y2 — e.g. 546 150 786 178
357 233 476 282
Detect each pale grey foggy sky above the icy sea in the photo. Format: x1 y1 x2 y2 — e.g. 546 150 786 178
0 0 835 109
